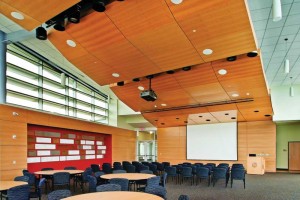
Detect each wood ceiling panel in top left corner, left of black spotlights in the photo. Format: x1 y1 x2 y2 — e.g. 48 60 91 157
0 0 79 31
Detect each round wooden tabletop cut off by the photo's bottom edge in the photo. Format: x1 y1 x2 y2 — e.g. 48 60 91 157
64 191 163 200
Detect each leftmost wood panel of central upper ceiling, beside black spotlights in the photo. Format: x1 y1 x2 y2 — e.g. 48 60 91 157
67 12 161 84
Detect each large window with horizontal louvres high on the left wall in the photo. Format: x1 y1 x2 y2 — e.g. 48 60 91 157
6 44 109 124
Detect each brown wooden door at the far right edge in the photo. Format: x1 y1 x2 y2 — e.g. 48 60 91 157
289 142 300 172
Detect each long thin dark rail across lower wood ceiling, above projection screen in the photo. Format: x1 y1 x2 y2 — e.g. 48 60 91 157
141 98 254 114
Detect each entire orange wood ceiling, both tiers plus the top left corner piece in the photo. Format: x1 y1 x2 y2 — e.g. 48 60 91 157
2 0 273 127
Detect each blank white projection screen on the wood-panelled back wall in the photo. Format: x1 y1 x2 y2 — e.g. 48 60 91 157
187 122 237 160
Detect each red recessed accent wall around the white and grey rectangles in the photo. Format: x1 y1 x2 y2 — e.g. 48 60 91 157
27 125 112 172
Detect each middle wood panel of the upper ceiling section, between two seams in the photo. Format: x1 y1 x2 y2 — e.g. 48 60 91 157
106 0 203 71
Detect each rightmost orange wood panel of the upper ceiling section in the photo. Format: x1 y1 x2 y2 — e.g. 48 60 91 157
166 0 257 62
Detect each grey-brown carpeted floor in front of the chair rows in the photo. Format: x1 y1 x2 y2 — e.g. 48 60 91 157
42 173 300 200
